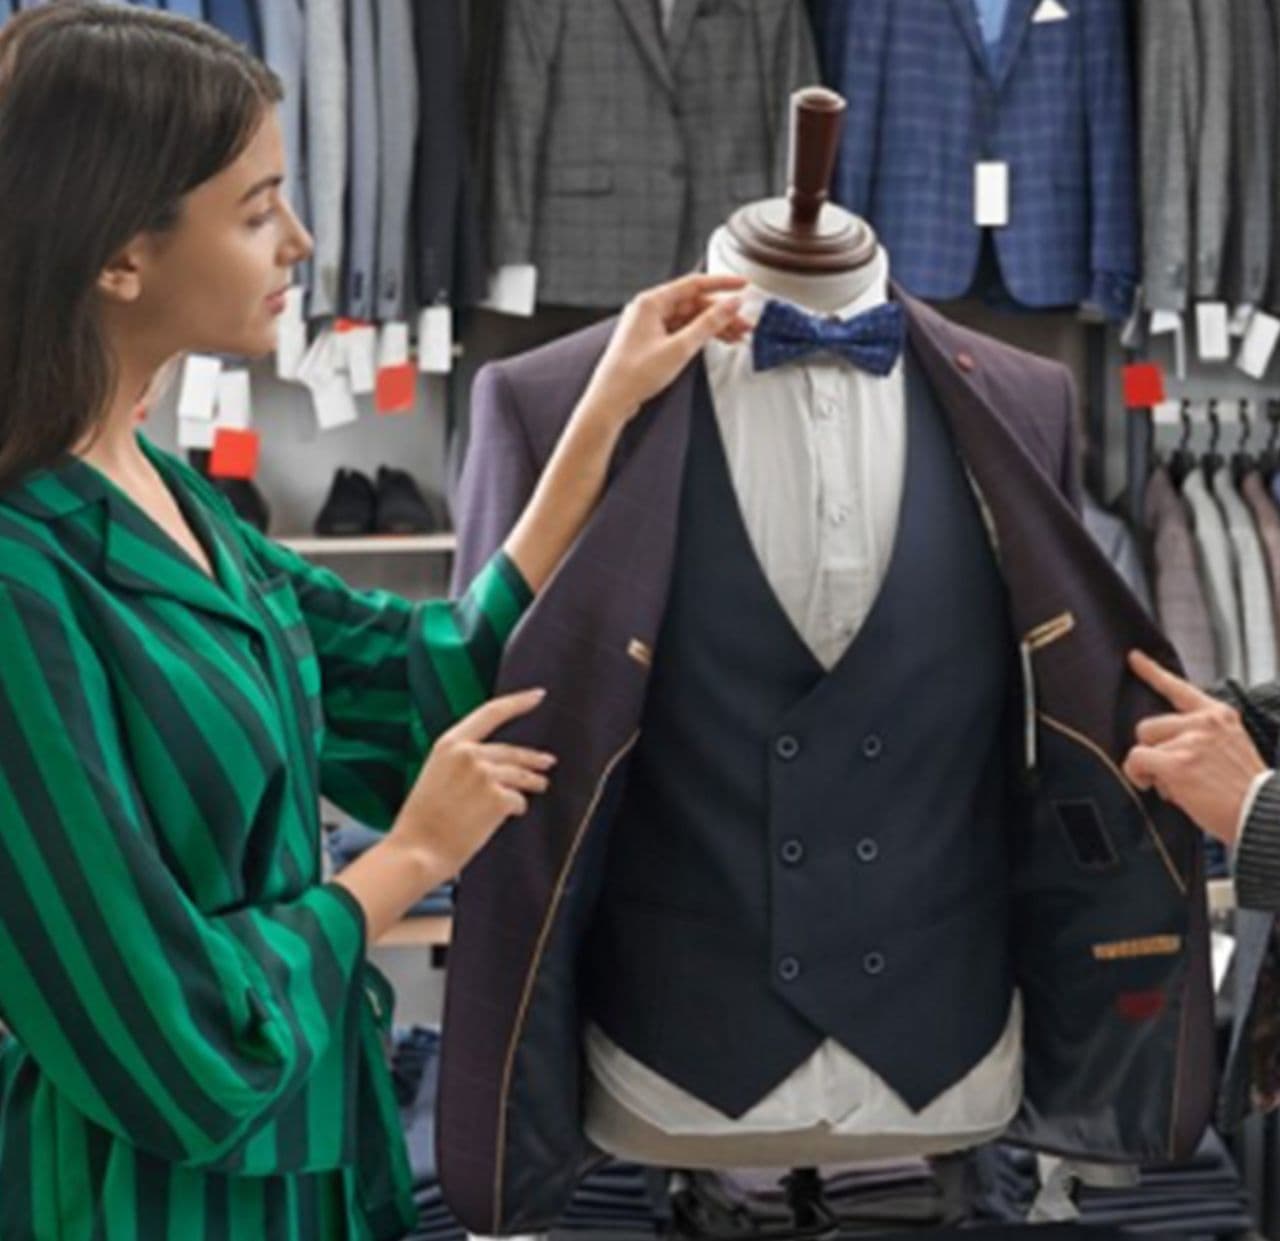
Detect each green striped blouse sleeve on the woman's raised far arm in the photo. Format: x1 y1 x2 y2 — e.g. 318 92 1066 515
242 527 532 828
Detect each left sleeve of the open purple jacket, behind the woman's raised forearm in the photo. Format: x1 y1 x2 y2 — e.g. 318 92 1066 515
453 363 539 596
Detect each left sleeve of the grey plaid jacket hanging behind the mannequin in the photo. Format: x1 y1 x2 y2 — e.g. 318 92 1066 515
490 0 563 267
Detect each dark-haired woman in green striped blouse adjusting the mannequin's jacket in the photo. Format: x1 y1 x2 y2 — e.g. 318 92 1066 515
0 0 745 1241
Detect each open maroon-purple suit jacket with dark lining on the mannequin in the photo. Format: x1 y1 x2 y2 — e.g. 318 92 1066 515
439 290 1213 1233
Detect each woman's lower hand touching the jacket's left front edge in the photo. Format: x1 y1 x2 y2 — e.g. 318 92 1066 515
389 690 556 879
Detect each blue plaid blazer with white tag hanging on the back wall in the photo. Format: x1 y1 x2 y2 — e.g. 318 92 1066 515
812 0 1138 317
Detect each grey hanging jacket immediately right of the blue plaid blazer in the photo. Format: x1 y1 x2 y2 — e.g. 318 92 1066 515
1139 0 1201 311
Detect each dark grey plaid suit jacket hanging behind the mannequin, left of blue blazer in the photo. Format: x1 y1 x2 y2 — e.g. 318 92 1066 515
492 0 818 307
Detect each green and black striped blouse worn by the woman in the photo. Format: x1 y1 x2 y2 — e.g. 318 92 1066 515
0 439 530 1241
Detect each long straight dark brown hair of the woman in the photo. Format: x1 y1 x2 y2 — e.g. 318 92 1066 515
0 0 283 487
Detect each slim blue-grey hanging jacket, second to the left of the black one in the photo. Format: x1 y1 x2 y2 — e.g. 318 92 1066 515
343 0 381 319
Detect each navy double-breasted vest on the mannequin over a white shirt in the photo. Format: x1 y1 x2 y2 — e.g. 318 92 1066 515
582 358 1016 1117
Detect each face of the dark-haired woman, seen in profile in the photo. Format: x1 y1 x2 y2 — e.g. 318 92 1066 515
122 107 312 357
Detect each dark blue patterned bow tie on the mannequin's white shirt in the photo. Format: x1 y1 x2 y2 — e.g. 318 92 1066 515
751 301 906 376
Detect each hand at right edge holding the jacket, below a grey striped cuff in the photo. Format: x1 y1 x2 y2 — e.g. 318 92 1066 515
1124 651 1268 846
